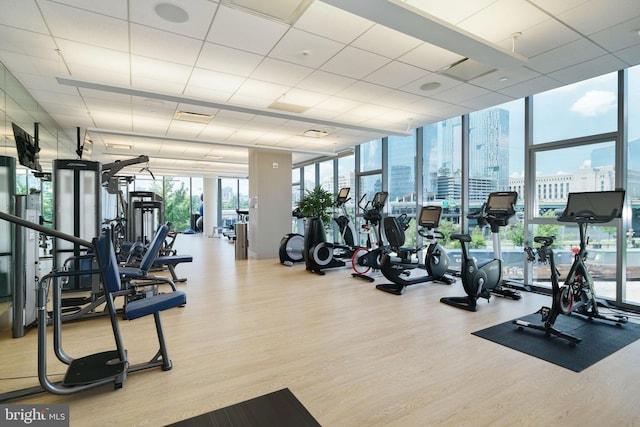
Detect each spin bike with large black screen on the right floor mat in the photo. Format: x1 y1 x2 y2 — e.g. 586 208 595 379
513 191 629 346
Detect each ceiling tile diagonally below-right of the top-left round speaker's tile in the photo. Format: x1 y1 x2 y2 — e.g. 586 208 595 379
196 43 263 77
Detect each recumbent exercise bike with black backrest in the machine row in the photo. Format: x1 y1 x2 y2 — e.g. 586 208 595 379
376 206 456 295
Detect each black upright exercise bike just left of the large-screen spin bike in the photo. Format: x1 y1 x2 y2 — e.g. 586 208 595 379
440 191 521 311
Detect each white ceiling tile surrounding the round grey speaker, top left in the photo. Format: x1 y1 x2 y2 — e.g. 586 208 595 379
128 0 218 40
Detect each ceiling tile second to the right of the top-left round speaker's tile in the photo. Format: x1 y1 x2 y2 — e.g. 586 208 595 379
269 28 345 68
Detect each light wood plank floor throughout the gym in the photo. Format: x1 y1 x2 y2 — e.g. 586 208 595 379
0 235 640 427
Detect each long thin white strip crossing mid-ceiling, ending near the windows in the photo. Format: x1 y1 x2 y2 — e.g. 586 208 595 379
56 77 412 137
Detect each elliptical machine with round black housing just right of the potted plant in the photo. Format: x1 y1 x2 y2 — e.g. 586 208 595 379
303 187 355 274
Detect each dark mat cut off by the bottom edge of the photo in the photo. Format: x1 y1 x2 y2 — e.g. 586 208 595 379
167 388 320 427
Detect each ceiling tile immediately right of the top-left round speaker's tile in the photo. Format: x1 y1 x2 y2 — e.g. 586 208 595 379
207 6 288 55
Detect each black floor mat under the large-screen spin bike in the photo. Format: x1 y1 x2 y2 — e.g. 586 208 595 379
473 314 640 372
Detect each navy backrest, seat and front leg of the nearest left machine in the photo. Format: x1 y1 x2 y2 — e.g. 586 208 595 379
95 232 187 373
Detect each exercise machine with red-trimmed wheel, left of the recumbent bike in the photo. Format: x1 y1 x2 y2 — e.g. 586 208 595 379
351 191 390 282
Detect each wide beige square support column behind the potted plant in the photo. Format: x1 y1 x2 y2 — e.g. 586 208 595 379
248 149 291 259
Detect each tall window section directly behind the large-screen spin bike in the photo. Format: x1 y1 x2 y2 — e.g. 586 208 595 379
522 73 618 299
